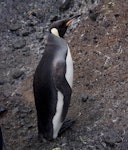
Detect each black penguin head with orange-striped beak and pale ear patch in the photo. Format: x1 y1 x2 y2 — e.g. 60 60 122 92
50 15 80 38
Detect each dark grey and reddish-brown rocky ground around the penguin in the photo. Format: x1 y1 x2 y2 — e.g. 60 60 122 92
0 0 128 150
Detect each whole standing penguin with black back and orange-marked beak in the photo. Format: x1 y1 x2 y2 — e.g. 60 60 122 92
33 15 79 141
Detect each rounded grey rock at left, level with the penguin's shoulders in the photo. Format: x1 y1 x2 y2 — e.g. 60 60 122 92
13 39 26 49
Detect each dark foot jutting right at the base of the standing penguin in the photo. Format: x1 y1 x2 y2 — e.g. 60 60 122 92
58 120 76 136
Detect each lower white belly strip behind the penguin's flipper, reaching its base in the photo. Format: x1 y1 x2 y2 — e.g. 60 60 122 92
52 91 64 139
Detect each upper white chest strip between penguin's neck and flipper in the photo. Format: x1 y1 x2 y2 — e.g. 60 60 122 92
66 47 73 88
